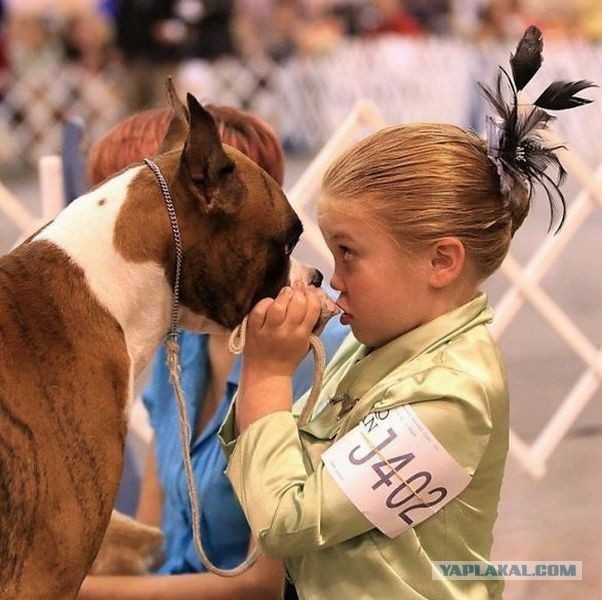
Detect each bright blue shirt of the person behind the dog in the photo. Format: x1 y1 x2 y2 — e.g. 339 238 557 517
142 320 348 574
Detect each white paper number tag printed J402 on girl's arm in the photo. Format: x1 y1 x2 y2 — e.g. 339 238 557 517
322 405 471 538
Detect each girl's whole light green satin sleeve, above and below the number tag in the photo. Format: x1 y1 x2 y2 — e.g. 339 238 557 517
221 369 491 557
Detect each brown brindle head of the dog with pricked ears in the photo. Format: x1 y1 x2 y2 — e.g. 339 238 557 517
118 86 321 329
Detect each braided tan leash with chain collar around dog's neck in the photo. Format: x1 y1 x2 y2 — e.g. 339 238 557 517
144 158 326 577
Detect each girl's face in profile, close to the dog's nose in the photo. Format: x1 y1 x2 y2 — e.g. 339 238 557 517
318 197 432 348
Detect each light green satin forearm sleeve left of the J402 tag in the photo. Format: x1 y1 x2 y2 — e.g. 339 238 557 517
222 411 374 557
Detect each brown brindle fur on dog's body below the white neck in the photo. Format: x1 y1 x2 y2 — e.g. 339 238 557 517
0 241 129 600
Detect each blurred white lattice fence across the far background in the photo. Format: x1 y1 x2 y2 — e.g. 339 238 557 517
0 36 602 169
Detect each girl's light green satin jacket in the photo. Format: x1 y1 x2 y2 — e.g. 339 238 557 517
221 294 508 600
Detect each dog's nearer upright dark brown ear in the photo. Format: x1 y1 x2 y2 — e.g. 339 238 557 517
182 94 240 213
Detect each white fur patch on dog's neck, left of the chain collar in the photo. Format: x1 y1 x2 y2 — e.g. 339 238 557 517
35 167 172 378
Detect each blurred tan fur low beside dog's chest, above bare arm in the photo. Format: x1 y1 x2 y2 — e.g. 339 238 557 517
89 510 163 575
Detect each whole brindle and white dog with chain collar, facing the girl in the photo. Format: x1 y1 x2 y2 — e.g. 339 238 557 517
0 86 319 600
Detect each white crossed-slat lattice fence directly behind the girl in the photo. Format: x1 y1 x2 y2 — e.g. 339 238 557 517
288 101 602 478
